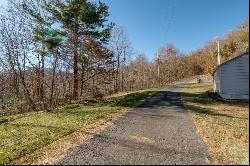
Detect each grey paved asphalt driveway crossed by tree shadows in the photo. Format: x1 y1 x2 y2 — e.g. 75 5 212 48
56 86 212 165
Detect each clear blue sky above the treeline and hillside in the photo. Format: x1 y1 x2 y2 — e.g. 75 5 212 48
0 0 249 60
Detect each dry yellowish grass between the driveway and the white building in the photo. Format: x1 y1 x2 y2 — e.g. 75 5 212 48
182 84 249 165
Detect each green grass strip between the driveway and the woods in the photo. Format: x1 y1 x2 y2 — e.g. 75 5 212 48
0 89 158 165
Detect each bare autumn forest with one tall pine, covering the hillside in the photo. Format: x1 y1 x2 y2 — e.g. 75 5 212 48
0 0 249 116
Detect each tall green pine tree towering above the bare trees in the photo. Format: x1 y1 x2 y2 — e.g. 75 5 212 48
24 0 113 99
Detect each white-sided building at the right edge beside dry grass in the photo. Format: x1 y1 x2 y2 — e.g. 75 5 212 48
213 52 249 101
